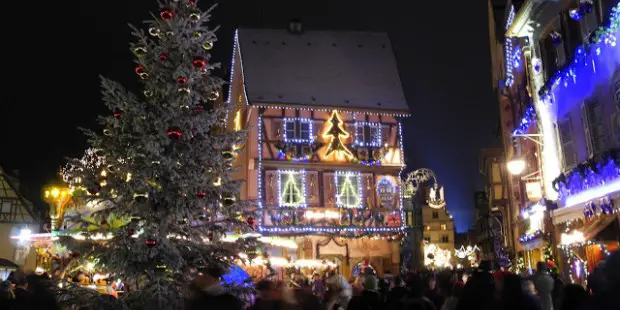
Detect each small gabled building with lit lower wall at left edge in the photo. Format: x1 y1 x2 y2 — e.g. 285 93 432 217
0 167 39 280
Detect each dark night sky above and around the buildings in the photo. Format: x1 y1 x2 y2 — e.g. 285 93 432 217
0 0 498 231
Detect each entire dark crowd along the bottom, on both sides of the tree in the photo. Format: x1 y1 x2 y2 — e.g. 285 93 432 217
0 252 620 310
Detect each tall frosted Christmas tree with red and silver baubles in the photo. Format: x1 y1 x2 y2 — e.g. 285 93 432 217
61 0 248 309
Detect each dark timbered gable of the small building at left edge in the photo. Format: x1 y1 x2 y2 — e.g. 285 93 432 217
0 167 35 224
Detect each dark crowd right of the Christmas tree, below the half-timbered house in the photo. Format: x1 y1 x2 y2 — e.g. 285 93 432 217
240 252 620 310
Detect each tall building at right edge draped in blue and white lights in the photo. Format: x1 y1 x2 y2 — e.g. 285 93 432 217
495 0 620 283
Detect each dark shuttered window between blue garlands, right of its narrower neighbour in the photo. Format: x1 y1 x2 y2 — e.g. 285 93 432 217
582 98 607 156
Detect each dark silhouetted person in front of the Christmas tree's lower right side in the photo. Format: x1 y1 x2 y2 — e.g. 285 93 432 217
186 266 243 310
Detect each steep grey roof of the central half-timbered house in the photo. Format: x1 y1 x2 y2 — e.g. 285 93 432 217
238 29 409 113
